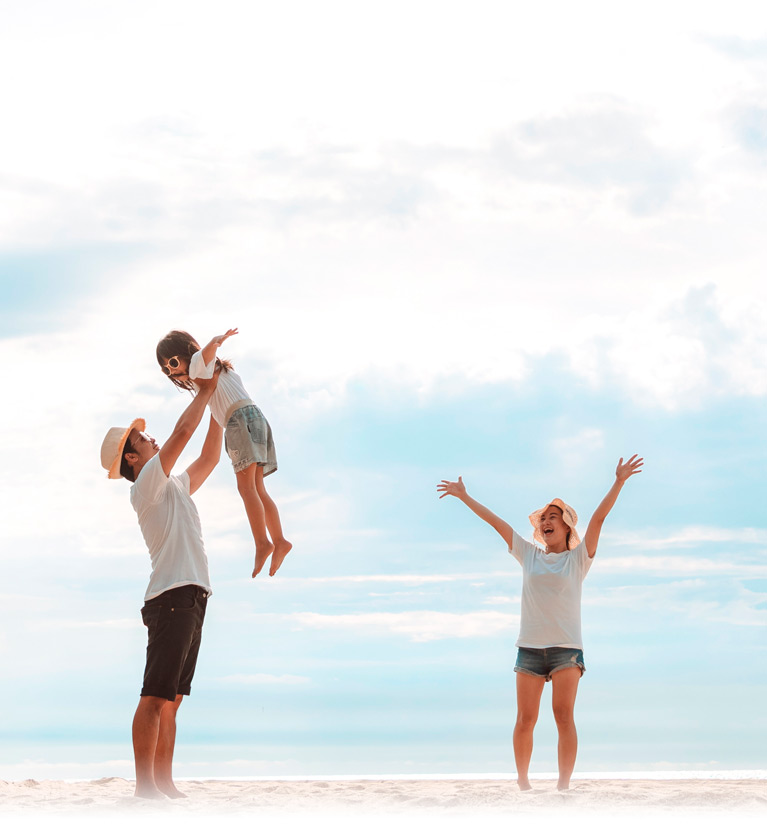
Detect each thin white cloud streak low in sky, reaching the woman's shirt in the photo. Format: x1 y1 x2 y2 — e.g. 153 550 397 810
290 610 519 642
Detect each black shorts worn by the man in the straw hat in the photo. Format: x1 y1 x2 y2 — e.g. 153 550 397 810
141 585 208 700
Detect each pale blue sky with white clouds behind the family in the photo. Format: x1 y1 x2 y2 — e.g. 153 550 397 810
0 0 767 779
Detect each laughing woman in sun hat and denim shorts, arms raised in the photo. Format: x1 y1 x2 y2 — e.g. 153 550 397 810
437 455 644 791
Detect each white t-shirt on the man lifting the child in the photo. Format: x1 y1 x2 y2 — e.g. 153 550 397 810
130 453 213 601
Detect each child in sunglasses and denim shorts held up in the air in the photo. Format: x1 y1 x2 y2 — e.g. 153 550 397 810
157 329 293 577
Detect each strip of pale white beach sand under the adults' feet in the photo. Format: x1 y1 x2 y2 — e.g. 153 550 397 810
0 778 767 812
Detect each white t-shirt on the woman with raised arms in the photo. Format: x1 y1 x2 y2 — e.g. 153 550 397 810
509 531 593 650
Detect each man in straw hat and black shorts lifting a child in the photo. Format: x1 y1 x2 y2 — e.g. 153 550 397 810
101 376 223 799
